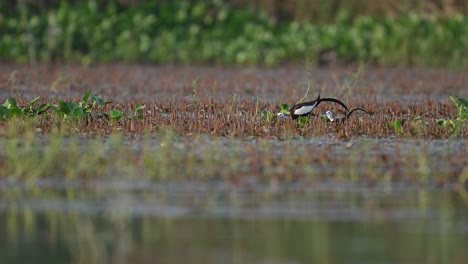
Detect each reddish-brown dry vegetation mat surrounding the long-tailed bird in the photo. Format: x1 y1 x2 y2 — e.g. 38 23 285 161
0 64 468 139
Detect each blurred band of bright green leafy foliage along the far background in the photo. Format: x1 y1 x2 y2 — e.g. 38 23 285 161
0 1 468 68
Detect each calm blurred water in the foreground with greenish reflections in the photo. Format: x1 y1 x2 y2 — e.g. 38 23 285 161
0 179 468 263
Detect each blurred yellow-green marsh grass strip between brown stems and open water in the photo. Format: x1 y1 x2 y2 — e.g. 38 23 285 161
0 125 468 186
